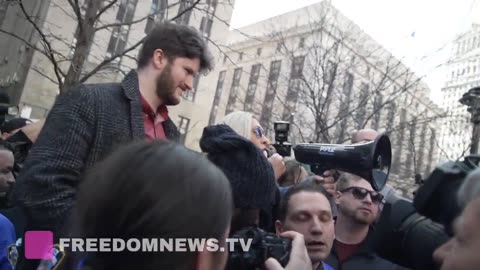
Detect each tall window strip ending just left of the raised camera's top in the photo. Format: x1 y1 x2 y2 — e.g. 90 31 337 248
260 60 282 131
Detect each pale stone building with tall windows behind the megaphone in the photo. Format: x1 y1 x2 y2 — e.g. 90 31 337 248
210 1 443 197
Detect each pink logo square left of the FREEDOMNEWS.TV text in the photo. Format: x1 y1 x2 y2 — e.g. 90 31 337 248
25 231 53 260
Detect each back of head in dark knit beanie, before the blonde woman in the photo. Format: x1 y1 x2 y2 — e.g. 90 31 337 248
200 125 277 209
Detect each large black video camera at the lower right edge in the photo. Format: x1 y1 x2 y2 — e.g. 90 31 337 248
372 155 480 270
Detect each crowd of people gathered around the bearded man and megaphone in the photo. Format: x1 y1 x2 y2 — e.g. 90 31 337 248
0 23 480 270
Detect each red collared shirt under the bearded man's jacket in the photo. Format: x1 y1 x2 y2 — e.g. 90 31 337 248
142 97 168 140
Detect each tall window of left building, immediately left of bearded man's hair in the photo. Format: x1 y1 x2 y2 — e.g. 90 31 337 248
107 0 137 63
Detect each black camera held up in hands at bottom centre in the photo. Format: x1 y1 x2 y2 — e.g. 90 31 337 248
226 227 292 270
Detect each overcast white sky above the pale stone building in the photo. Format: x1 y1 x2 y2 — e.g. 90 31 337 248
232 0 480 103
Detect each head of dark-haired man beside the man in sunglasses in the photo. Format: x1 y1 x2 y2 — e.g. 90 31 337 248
275 183 335 270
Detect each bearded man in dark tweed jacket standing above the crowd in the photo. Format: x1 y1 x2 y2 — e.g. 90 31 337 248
14 23 213 238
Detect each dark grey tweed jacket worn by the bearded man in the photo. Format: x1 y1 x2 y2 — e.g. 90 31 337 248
14 71 179 238
